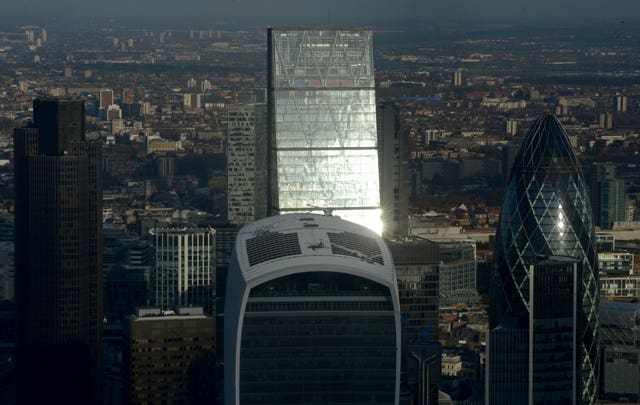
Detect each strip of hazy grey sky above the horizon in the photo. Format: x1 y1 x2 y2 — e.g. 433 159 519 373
2 0 640 21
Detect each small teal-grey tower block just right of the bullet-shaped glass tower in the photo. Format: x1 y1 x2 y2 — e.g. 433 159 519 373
589 163 627 229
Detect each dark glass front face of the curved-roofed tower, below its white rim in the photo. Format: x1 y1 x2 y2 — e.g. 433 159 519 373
240 272 396 405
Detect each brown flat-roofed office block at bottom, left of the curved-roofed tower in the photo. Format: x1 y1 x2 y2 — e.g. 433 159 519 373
122 307 216 405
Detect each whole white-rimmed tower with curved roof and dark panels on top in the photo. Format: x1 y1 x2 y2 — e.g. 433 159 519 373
224 214 401 405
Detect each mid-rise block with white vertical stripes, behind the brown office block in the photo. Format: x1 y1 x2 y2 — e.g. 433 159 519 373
149 226 216 314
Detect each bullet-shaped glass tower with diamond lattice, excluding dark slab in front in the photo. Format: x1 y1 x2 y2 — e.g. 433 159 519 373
487 114 599 404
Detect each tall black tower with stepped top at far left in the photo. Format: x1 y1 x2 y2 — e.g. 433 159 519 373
14 99 103 404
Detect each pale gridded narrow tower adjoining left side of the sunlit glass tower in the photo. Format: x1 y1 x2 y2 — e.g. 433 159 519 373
227 104 267 224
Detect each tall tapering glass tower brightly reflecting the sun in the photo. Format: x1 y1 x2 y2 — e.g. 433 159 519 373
267 28 381 234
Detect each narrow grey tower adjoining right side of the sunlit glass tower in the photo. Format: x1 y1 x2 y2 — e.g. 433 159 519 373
376 102 409 238
